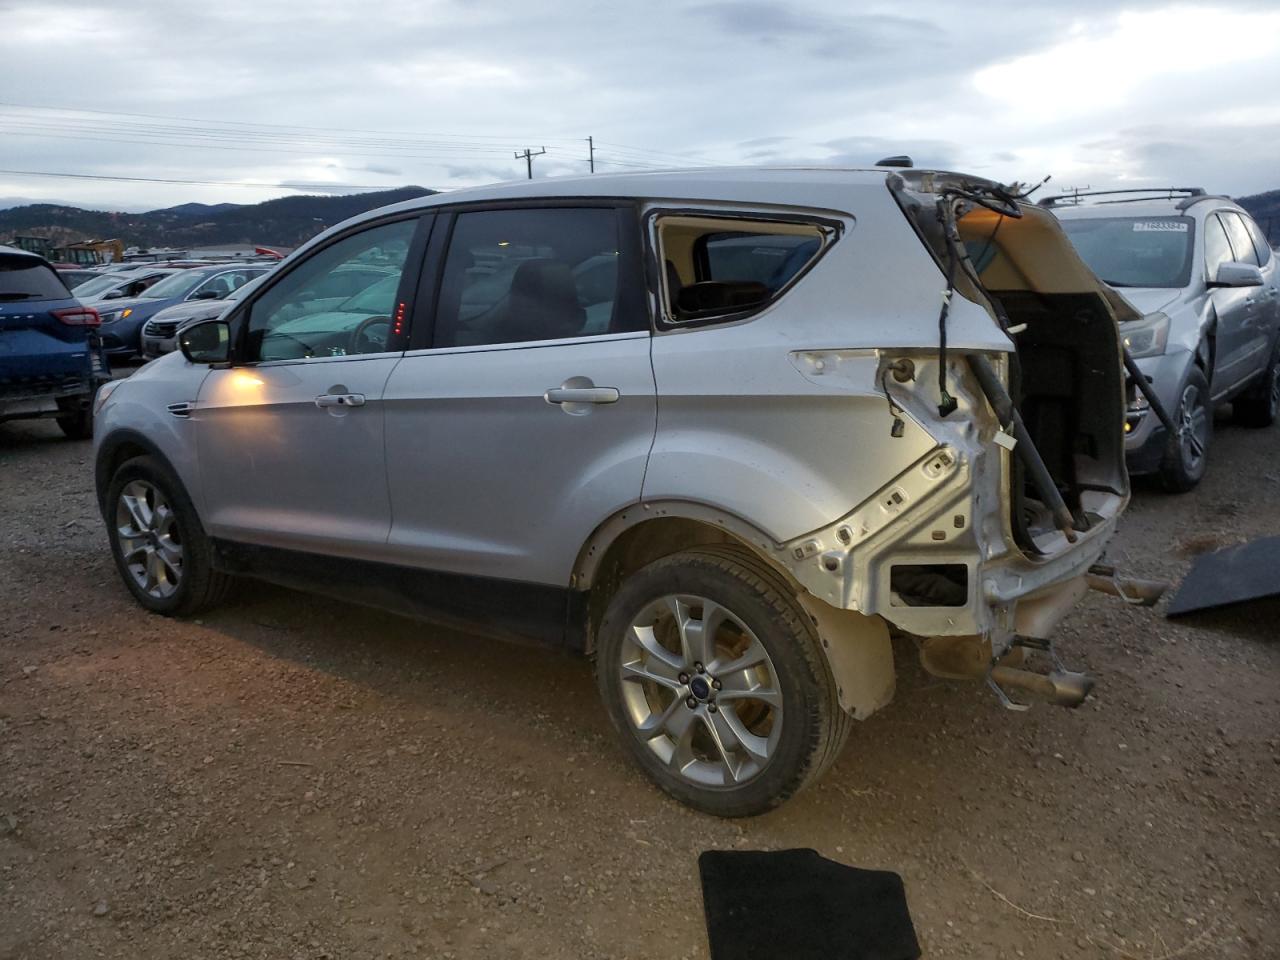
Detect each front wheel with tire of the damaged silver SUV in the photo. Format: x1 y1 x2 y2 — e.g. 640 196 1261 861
102 457 233 616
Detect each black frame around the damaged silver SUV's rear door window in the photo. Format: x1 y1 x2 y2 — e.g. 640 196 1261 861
406 196 653 355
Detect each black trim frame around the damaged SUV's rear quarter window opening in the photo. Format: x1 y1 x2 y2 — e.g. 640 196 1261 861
644 206 854 333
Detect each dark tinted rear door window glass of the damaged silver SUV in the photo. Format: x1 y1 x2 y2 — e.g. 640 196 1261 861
434 207 636 347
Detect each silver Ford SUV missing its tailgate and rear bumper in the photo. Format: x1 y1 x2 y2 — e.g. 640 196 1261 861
96 169 1137 815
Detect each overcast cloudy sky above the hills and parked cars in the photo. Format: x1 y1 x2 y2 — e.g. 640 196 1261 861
0 0 1280 210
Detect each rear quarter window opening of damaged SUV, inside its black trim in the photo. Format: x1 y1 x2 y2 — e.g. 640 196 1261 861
657 215 835 323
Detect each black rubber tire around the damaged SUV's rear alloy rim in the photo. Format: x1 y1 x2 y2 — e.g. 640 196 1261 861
595 554 833 817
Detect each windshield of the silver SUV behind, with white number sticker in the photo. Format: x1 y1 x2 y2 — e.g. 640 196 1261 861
1062 216 1193 287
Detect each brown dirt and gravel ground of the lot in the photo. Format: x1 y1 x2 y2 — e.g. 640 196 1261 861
0 407 1280 960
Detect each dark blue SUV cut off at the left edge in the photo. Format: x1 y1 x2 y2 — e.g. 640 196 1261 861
0 246 111 440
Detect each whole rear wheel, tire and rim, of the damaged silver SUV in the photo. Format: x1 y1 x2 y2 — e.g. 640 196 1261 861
595 545 852 817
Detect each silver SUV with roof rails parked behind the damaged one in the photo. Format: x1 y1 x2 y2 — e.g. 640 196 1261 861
1041 188 1280 493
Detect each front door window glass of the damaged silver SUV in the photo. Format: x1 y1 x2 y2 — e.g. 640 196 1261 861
247 220 417 361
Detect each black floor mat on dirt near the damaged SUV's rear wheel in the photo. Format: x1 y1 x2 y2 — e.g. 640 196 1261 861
698 850 920 960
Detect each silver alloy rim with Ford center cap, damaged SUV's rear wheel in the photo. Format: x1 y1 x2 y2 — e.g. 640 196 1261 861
618 595 782 787
